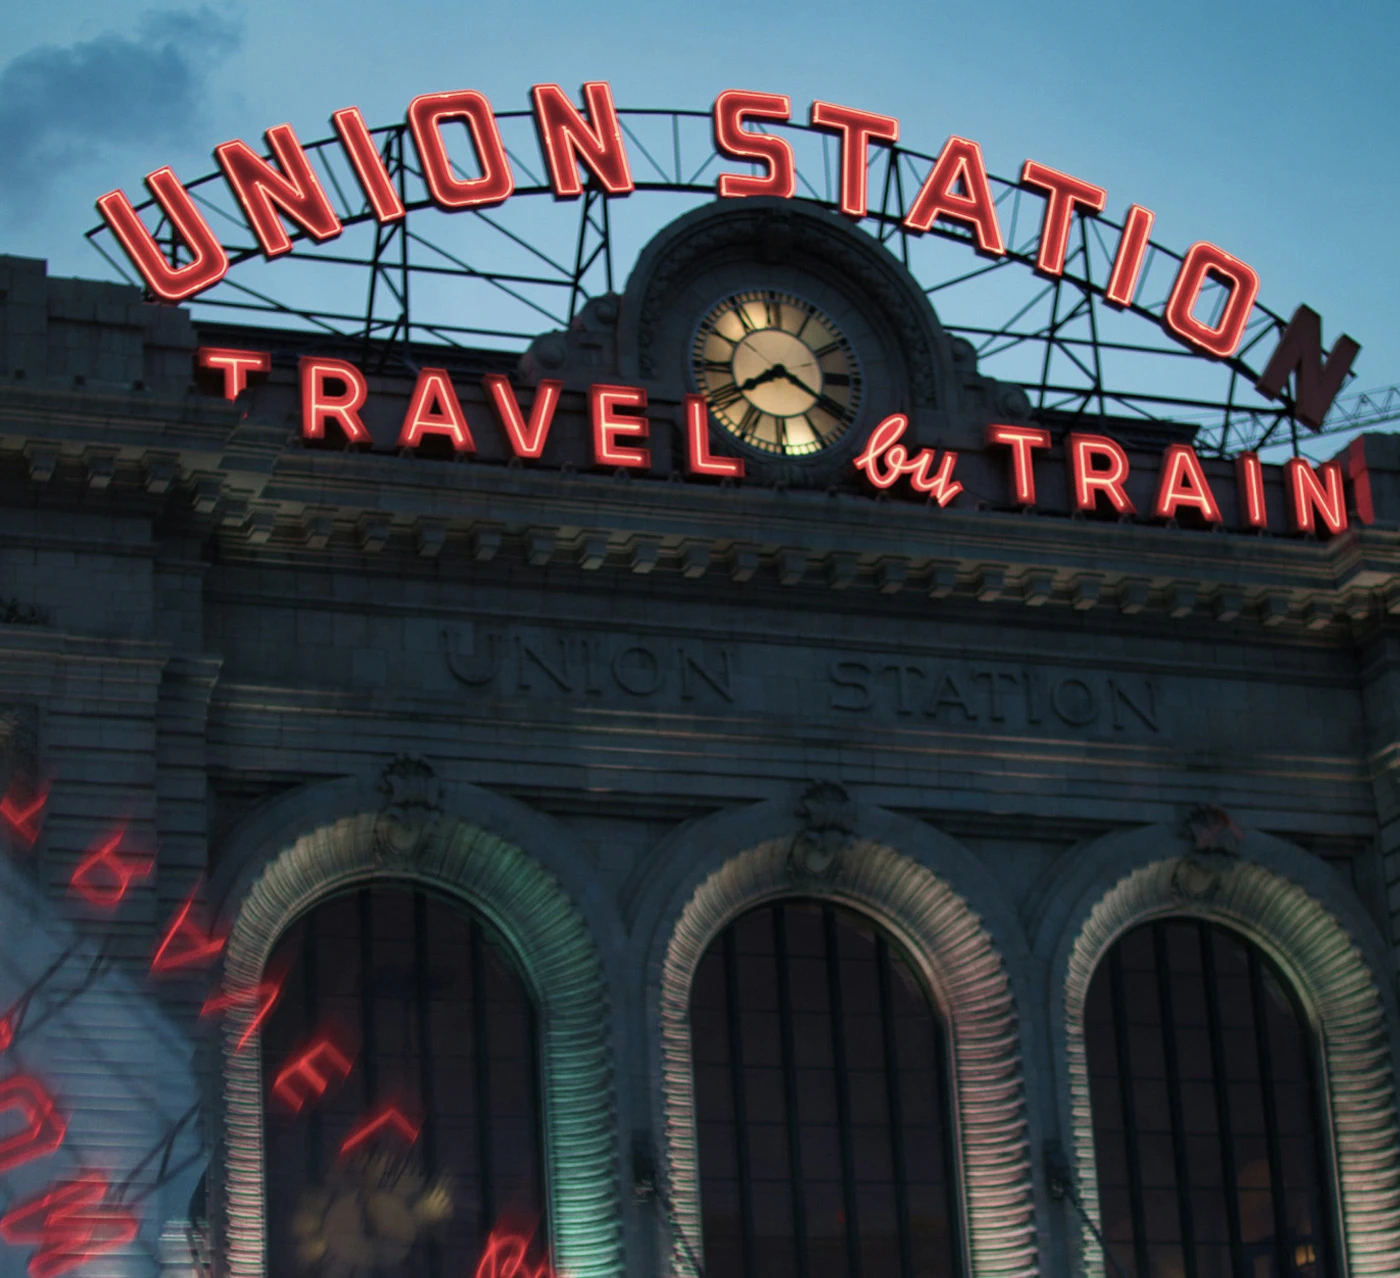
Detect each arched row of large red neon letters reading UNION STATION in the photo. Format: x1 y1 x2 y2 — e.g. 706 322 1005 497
97 80 1359 414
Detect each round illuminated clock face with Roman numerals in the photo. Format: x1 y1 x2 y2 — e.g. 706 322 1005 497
692 288 861 456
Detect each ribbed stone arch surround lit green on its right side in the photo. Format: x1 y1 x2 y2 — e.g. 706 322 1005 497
221 811 623 1278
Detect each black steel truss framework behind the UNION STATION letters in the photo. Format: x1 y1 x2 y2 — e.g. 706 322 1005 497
88 109 1377 455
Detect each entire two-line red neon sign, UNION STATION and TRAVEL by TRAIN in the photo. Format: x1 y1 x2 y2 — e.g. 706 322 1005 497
97 81 1371 533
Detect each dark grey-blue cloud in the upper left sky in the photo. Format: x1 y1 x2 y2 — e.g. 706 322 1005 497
0 7 241 209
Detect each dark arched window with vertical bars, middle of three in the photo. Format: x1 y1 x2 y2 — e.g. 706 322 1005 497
690 901 960 1278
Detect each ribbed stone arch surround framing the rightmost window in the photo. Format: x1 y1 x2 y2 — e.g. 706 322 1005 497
1064 855 1400 1278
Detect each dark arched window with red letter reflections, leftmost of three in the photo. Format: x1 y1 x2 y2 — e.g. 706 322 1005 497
262 886 547 1278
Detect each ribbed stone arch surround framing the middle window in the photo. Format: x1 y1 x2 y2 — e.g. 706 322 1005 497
659 834 1039 1278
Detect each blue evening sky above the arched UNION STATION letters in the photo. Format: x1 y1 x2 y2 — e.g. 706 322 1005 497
0 0 1400 422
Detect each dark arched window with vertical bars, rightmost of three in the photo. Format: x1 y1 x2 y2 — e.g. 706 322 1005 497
1084 920 1337 1278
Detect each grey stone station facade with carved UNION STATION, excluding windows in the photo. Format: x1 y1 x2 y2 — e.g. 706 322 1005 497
0 242 1400 1278
